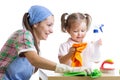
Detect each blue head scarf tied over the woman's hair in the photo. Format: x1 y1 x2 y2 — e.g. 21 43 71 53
28 5 52 26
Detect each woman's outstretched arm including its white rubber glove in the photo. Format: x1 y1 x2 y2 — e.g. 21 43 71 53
24 51 91 74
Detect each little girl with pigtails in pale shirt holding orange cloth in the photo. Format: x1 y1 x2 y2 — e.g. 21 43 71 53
58 13 102 67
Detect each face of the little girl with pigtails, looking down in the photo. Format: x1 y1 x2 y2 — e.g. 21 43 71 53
68 21 87 43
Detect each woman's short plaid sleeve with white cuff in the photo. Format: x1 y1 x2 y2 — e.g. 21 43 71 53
15 30 37 54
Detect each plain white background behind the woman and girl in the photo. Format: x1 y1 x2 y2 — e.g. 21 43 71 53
0 0 120 79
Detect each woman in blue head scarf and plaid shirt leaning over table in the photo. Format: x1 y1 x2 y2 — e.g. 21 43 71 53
0 5 90 80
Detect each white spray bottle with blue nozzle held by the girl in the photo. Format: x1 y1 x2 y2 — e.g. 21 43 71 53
92 24 104 63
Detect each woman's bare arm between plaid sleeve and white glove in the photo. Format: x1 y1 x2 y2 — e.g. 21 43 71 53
24 51 57 71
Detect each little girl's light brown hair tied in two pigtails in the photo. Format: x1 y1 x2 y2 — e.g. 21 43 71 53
61 12 92 32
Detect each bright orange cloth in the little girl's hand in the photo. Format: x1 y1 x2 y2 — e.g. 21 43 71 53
71 43 87 67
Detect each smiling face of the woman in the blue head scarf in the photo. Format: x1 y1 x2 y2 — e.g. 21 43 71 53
34 16 54 40
